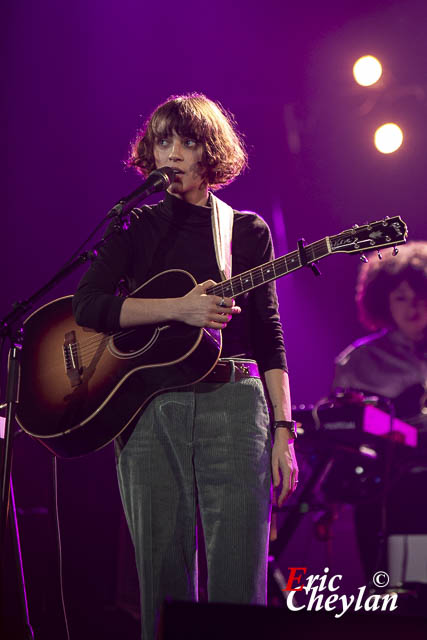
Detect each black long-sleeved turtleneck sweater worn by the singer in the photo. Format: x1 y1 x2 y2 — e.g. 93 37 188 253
73 193 287 371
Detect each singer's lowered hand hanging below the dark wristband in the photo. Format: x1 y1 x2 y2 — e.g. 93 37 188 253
271 428 298 507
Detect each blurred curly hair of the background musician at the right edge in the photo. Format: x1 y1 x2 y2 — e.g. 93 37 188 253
356 242 427 331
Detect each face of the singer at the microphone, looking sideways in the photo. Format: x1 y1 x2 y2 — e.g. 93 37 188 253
153 132 208 204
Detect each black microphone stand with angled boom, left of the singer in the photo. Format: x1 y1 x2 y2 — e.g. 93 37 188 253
0 196 147 640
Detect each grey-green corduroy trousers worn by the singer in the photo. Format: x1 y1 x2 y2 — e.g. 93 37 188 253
117 370 271 640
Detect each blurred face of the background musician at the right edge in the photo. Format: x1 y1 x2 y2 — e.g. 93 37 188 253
389 280 427 340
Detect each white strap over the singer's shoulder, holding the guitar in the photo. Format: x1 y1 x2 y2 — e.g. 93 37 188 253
211 193 234 280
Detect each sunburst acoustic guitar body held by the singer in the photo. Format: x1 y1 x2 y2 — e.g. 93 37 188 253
17 270 222 457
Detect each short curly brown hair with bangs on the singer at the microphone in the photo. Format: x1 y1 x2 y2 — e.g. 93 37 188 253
128 93 248 190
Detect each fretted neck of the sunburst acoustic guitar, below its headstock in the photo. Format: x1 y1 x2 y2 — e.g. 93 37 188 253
206 236 332 298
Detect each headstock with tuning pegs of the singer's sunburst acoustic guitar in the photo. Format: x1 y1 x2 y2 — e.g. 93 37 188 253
329 216 408 253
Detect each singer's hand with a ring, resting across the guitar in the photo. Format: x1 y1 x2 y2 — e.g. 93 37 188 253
176 280 241 329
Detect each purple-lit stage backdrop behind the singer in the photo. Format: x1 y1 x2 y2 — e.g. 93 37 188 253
0 0 427 636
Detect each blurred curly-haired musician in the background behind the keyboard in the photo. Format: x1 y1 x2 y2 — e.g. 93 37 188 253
333 242 427 580
